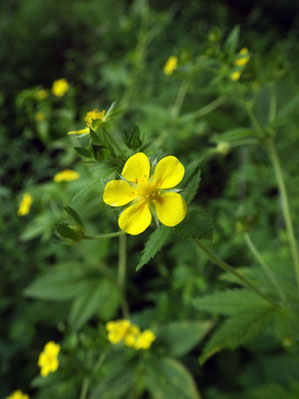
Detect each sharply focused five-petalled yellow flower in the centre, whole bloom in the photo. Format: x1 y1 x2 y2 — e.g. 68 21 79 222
103 152 187 235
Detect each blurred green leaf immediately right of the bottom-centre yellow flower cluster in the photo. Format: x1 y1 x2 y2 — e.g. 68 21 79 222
157 320 213 356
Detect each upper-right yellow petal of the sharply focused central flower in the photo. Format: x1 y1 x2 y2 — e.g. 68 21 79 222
154 155 185 188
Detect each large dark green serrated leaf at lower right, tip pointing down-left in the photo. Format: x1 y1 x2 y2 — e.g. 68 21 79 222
200 302 276 364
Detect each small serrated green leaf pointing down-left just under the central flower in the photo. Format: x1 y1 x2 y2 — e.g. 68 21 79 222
136 226 171 271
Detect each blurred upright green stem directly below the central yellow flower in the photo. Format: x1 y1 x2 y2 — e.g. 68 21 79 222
118 235 129 319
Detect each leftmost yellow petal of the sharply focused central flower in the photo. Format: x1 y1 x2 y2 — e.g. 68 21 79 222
103 180 137 206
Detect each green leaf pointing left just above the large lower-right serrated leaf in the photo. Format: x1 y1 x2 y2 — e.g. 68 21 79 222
193 288 264 316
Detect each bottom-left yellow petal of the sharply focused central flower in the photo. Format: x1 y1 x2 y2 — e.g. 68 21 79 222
118 201 152 235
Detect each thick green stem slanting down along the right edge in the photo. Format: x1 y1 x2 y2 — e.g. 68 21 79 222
267 140 299 289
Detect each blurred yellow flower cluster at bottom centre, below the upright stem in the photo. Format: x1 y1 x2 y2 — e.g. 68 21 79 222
106 320 156 350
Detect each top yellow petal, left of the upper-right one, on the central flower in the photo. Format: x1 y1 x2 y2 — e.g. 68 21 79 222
121 152 151 184
